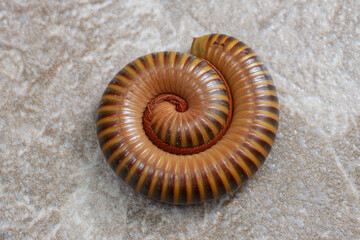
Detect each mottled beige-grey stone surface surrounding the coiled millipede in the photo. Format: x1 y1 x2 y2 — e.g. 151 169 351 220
0 0 360 239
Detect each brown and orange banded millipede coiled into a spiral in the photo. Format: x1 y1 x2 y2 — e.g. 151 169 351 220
97 34 279 204
